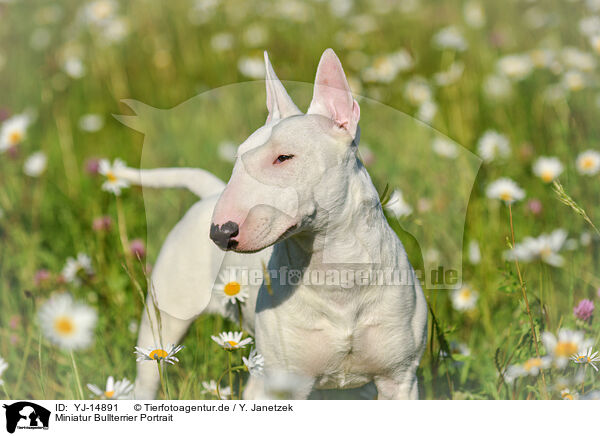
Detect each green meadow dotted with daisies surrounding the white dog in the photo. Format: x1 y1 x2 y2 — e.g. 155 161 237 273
0 0 600 399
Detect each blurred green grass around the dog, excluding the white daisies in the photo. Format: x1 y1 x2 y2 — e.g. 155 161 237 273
0 0 600 399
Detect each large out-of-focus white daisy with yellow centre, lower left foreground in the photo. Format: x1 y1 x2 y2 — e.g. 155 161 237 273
38 293 98 350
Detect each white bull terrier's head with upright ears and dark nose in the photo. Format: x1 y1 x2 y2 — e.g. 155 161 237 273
210 49 360 252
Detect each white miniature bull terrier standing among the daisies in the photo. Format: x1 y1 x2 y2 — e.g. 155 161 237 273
118 49 427 399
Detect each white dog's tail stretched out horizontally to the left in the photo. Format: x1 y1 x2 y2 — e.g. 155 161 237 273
115 167 225 198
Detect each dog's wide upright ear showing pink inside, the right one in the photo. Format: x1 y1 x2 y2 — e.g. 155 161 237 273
307 48 360 139
